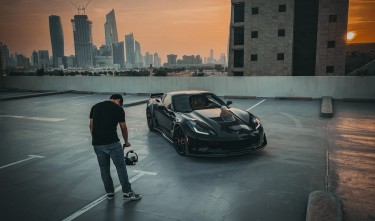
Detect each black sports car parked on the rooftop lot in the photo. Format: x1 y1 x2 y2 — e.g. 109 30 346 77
146 90 267 156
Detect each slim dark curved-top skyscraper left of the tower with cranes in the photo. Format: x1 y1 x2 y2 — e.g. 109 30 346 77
49 15 64 67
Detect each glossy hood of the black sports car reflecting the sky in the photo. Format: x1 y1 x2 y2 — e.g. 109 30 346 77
185 106 254 135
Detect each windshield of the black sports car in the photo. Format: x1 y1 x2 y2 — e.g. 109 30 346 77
172 94 225 112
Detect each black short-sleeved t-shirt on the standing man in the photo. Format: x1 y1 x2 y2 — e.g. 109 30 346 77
90 101 125 145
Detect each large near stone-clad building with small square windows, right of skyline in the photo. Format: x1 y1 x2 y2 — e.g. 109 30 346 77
228 0 348 76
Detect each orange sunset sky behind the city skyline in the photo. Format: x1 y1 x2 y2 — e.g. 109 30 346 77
0 0 375 62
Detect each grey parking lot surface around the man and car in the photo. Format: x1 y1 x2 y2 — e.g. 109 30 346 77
0 92 375 221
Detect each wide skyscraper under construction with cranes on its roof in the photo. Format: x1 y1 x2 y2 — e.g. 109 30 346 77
71 15 93 68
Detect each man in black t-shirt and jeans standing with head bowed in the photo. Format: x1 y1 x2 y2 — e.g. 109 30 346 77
89 94 141 200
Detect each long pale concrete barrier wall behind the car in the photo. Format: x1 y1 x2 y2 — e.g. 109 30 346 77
2 76 375 99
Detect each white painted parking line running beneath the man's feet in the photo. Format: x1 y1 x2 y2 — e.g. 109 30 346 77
63 170 157 221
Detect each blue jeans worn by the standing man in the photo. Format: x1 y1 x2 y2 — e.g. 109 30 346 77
94 142 132 193
